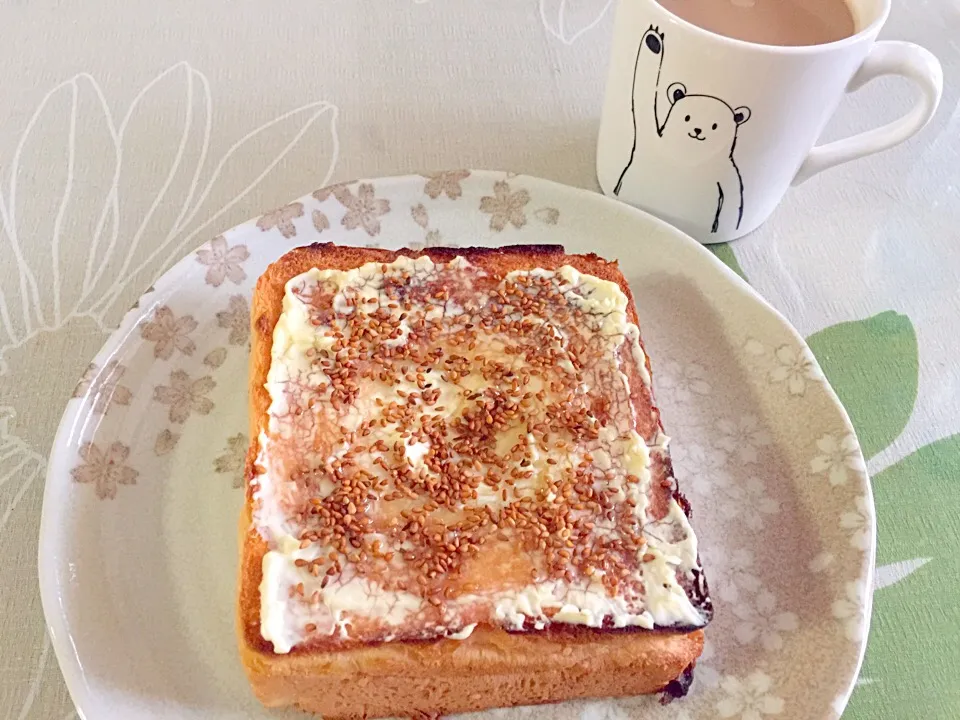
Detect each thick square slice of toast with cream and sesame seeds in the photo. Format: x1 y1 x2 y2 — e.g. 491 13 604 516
239 244 712 718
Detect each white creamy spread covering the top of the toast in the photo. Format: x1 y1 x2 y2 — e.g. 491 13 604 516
254 257 706 653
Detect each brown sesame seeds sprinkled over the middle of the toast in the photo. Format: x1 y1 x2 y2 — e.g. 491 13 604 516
262 266 672 620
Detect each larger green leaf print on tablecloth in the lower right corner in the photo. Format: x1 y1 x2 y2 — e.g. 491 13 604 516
844 435 960 720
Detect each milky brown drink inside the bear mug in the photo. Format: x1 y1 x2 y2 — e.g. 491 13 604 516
657 0 857 45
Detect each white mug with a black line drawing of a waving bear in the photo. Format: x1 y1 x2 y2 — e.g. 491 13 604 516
597 0 943 243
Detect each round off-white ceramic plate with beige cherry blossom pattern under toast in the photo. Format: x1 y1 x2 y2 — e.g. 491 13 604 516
40 171 874 720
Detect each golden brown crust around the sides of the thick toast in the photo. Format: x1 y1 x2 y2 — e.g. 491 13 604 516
238 244 703 718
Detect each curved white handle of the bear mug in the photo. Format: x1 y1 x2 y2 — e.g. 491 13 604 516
793 40 943 185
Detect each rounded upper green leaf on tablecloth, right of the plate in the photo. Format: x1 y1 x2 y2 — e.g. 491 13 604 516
807 312 919 459
